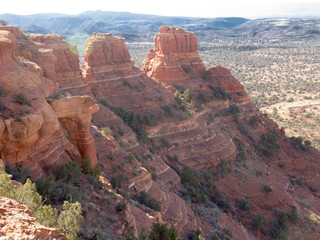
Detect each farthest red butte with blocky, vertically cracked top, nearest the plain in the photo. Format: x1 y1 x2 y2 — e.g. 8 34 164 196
142 26 206 84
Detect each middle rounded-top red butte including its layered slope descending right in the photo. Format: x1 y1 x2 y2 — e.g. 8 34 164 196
83 33 175 114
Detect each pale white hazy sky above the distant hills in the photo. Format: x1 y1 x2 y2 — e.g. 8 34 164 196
0 0 320 18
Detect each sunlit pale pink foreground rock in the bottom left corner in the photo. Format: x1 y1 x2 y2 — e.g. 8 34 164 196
0 197 67 240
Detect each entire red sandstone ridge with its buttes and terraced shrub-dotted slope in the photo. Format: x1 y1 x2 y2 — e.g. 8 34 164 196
0 26 320 239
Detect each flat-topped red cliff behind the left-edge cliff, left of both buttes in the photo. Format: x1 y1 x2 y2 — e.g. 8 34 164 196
15 30 90 95
